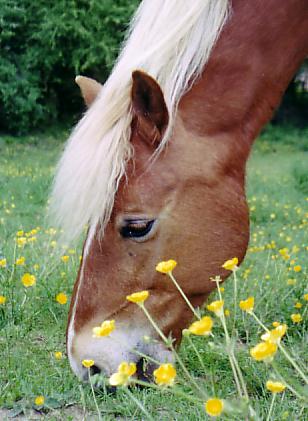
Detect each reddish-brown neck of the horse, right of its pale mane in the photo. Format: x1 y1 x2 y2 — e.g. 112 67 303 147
179 0 308 148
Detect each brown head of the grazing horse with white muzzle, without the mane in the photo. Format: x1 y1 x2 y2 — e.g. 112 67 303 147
68 71 248 377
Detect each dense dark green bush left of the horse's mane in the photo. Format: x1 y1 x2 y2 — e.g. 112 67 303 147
0 0 138 133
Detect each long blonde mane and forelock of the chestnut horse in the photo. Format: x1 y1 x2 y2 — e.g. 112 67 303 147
51 0 229 241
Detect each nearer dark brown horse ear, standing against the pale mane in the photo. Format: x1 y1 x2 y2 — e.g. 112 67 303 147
131 70 169 146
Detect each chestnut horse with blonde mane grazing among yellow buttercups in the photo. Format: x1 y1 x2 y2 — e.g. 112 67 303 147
53 0 308 378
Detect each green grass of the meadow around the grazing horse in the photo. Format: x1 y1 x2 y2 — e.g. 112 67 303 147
0 127 308 420
